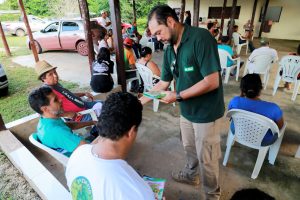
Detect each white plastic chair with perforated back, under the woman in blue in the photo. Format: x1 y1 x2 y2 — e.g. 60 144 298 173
223 109 286 179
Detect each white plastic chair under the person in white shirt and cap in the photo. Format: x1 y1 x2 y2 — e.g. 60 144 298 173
243 54 274 89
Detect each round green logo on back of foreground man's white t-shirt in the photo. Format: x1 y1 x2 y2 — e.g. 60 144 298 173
71 176 93 200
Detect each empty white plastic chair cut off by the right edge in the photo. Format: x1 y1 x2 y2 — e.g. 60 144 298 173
273 56 300 101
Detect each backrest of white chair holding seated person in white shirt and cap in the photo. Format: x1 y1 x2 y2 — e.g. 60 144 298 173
248 54 274 74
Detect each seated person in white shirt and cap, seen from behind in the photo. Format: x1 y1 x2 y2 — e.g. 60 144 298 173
248 38 278 69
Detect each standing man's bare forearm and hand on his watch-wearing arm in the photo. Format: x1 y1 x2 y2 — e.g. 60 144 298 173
162 72 220 103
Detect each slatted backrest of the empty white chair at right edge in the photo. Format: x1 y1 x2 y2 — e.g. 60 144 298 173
279 56 300 82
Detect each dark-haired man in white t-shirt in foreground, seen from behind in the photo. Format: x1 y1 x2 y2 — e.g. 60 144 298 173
66 92 155 200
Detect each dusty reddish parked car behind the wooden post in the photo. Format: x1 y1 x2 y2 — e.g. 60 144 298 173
27 20 97 56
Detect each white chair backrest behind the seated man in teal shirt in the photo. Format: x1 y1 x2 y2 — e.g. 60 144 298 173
29 133 69 166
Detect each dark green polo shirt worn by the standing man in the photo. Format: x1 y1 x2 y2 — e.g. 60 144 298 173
161 25 225 123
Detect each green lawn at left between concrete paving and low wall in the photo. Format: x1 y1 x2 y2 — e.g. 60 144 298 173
0 50 78 123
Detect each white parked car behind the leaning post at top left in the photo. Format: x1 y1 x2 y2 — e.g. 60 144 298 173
2 15 47 36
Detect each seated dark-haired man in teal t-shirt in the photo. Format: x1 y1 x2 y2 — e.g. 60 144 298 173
28 86 94 156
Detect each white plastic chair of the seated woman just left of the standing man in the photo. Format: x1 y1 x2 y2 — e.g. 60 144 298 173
135 63 175 112
